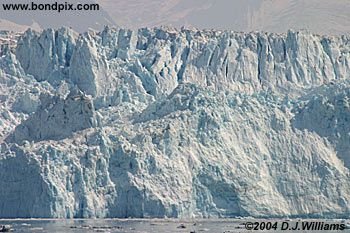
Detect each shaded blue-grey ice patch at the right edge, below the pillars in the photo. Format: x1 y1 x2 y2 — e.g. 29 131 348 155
292 89 350 169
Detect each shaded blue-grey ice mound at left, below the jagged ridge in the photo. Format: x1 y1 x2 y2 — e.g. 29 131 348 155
5 91 98 143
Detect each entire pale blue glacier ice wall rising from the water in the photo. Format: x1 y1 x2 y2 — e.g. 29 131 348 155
0 27 350 218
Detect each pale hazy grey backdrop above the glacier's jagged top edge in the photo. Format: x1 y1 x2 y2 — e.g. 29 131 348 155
0 0 350 34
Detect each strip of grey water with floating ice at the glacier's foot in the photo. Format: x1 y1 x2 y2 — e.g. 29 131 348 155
0 219 350 233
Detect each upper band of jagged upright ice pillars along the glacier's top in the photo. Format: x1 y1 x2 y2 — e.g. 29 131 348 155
16 27 350 99
